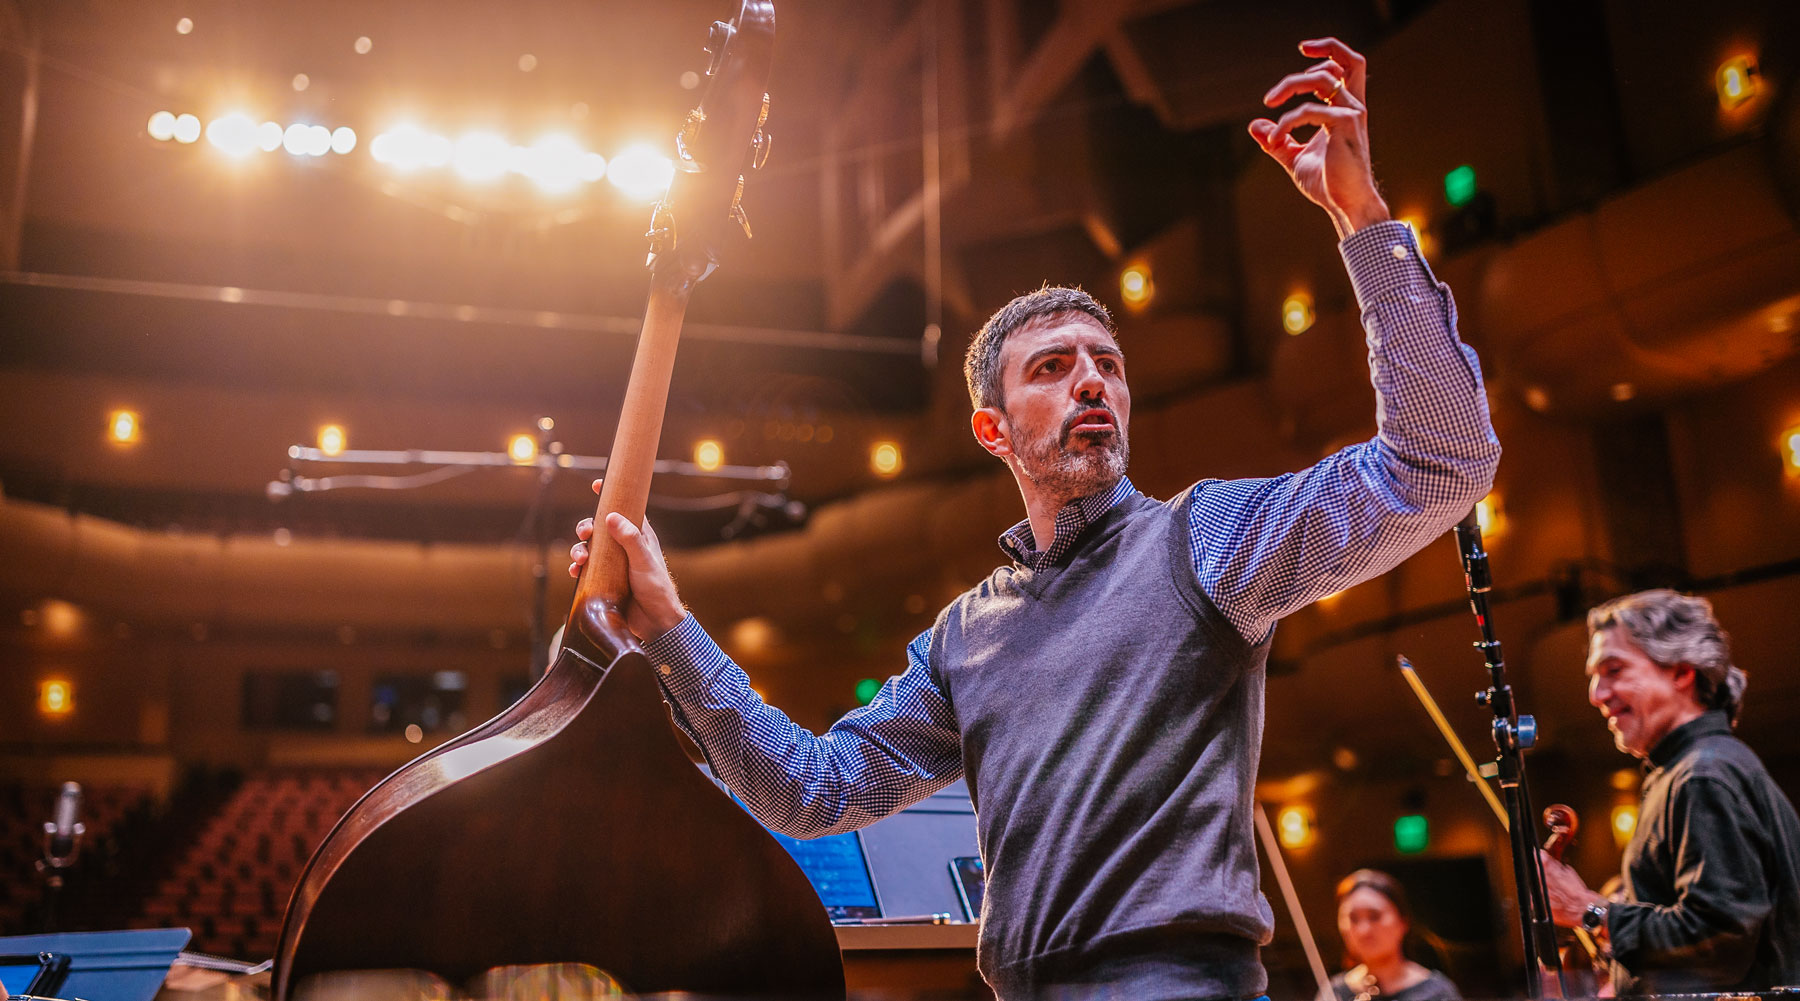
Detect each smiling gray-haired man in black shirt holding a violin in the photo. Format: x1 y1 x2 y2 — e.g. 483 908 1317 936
1544 591 1800 994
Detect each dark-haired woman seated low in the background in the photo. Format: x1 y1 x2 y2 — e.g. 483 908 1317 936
1332 870 1462 1001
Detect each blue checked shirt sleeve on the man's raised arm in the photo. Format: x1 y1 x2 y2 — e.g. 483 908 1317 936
1188 221 1499 643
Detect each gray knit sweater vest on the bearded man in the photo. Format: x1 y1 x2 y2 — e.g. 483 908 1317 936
931 490 1274 1001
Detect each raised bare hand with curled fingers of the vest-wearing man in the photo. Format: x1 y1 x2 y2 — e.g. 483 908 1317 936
1249 38 1390 239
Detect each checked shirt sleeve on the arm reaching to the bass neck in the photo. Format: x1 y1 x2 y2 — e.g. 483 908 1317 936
644 616 963 837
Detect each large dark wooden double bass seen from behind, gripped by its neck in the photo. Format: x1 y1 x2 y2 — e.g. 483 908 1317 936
270 0 844 1001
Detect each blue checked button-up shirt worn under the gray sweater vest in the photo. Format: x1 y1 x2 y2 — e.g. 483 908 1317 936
644 221 1499 837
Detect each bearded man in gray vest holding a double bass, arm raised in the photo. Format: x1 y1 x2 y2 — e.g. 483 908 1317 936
571 38 1499 1001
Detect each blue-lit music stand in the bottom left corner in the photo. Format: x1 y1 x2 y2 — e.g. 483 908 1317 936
0 927 194 1001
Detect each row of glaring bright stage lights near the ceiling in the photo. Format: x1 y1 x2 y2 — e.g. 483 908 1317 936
148 112 675 202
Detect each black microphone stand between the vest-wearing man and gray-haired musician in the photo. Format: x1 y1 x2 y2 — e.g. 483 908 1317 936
1456 511 1566 997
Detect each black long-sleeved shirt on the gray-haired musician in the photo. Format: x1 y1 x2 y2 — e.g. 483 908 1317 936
1607 711 1800 994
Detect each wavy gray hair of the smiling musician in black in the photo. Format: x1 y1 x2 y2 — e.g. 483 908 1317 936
1588 587 1750 724
